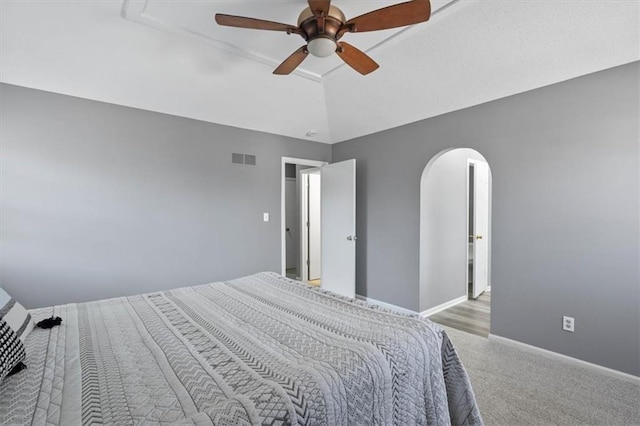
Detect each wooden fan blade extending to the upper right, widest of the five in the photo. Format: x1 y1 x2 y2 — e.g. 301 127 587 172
343 0 431 33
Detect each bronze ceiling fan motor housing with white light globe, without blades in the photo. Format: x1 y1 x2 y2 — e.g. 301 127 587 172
298 6 347 57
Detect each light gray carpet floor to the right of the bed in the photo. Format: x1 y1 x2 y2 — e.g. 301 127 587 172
443 327 640 426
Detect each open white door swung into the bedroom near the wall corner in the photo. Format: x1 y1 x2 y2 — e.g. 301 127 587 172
321 160 356 297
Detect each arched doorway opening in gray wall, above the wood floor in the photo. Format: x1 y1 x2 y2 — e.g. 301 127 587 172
420 148 491 333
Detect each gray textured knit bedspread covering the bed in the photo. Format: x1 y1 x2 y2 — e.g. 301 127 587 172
0 273 482 425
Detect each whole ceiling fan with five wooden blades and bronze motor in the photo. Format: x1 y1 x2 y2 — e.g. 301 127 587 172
216 0 431 75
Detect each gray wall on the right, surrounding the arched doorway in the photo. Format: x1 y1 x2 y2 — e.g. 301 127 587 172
333 62 640 375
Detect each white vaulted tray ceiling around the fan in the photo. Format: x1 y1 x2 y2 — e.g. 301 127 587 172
0 0 640 143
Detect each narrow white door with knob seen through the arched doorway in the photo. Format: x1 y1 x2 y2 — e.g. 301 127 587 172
473 161 489 299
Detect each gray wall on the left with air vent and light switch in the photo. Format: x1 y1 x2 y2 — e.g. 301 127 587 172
0 84 331 308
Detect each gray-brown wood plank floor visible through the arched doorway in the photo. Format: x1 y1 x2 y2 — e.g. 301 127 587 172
429 291 491 337
